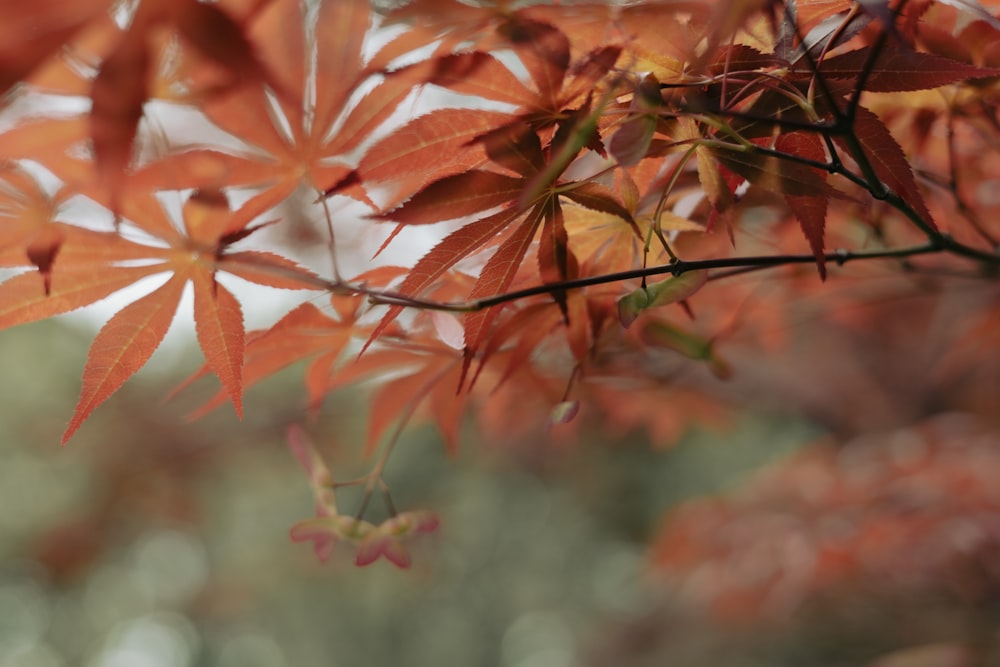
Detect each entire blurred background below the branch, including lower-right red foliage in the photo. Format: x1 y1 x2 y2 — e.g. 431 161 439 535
0 302 1000 667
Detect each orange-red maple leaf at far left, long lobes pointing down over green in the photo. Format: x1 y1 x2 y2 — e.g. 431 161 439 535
0 184 316 442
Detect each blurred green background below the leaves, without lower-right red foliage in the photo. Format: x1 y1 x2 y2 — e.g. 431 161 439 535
0 310 810 667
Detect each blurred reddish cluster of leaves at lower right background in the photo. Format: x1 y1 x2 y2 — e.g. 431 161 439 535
655 415 1000 619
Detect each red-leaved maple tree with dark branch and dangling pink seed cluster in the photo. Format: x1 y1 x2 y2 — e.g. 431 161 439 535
0 0 1000 588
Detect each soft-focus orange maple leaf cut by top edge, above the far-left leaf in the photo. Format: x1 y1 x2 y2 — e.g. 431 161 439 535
149 0 430 211
